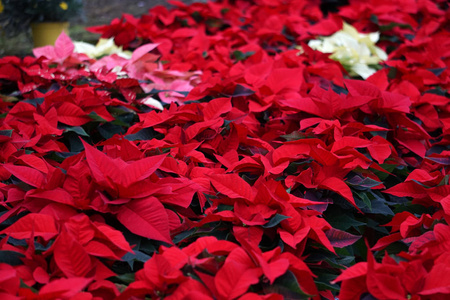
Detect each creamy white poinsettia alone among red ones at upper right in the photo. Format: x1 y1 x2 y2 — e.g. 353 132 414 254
308 23 387 79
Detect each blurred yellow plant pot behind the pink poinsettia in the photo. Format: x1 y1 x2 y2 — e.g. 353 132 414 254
31 22 69 48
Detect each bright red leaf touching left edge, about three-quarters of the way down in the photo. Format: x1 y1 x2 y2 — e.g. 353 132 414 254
0 213 59 241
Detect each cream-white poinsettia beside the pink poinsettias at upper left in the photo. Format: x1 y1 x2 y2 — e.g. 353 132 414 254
73 38 132 59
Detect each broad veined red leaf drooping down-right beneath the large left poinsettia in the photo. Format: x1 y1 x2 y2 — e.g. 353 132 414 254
117 197 172 244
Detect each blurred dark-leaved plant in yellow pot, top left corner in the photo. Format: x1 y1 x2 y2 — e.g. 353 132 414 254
0 0 83 47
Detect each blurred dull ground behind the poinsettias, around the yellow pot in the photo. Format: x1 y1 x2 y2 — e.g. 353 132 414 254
0 0 200 56
